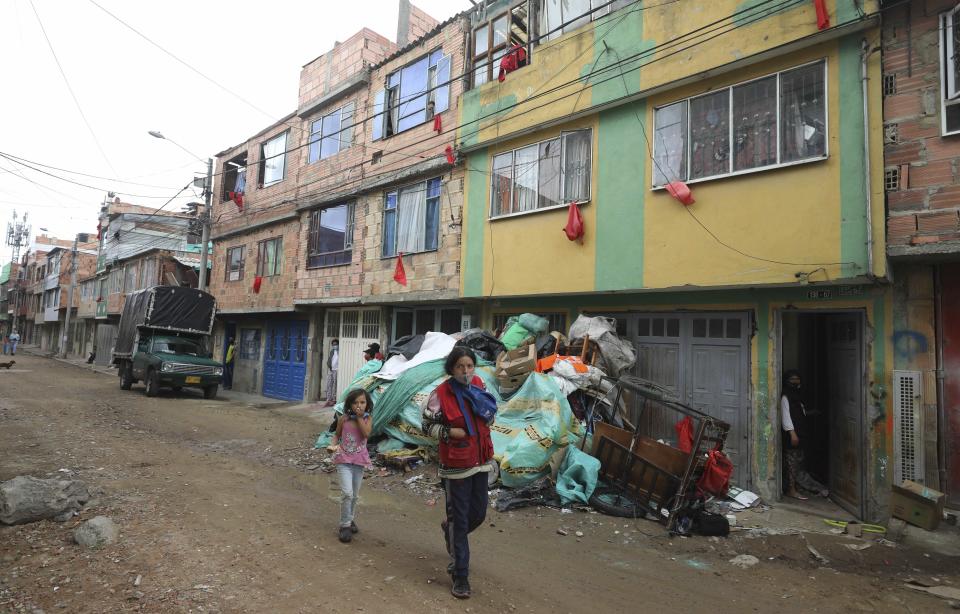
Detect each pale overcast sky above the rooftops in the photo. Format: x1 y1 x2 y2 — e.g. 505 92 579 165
0 0 470 251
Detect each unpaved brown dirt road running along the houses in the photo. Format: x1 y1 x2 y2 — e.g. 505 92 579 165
0 355 960 614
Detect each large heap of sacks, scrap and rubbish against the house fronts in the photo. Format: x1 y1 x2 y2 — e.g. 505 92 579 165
315 313 744 534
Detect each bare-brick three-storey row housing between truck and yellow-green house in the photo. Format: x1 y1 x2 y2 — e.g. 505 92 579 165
211 0 465 399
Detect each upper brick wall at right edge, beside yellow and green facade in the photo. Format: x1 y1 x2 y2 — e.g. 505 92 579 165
882 0 960 252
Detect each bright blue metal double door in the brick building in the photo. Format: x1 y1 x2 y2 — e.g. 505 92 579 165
263 321 308 401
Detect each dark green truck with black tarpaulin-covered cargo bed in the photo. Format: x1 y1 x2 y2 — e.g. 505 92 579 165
113 286 223 399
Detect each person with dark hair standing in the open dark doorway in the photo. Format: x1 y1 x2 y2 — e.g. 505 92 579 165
780 369 830 501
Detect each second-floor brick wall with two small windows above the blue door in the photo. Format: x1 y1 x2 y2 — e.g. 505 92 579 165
209 219 302 312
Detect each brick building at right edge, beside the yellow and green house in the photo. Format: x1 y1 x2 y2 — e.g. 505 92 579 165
882 0 960 510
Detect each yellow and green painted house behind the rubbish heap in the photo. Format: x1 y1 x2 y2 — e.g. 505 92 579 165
457 0 893 518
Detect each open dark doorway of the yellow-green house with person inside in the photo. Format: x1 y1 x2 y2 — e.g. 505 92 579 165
777 310 864 518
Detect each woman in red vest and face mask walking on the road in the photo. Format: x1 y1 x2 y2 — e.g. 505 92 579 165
423 346 497 599
